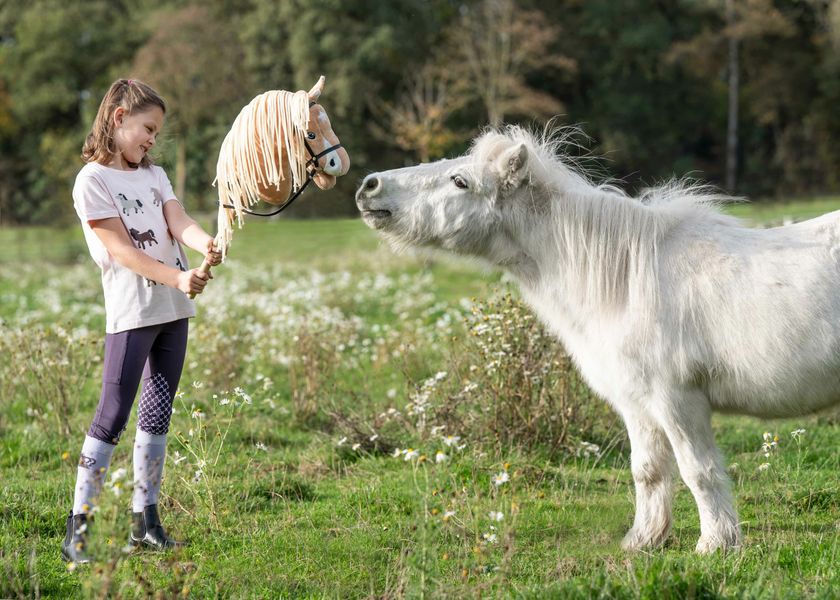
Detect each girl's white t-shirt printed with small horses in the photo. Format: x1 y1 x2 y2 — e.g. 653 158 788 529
73 162 195 333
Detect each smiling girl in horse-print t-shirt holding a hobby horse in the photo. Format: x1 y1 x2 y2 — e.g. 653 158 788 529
61 79 221 563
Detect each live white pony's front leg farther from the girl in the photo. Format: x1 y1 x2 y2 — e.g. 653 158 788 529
653 390 741 554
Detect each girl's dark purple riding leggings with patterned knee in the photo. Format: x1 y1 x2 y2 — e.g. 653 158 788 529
88 319 189 444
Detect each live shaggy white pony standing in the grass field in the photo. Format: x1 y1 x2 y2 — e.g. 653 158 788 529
356 127 840 553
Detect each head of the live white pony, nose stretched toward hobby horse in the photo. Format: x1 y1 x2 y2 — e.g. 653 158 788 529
356 128 547 263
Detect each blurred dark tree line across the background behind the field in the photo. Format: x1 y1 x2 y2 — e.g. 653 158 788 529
0 0 840 224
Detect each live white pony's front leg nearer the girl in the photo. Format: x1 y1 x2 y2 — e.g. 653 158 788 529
621 414 674 550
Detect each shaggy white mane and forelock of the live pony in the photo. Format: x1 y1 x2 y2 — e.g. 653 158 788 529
470 125 740 305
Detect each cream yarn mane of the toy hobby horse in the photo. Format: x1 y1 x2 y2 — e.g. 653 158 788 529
213 90 309 254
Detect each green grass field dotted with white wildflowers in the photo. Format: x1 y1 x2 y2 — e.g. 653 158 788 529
0 204 840 599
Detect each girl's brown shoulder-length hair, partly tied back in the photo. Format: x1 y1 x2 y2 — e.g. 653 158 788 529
82 79 166 167
